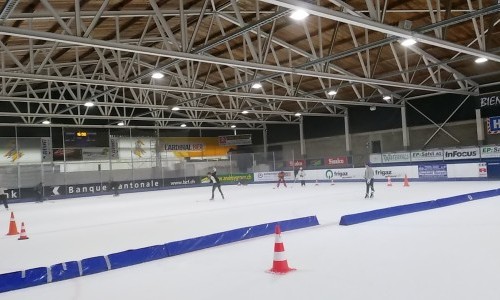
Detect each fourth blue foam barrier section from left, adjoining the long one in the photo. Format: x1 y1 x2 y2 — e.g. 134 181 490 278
108 245 168 269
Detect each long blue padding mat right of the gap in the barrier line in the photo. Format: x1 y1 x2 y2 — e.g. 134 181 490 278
340 189 500 225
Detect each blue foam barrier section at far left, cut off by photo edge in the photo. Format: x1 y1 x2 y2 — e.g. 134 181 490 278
0 267 48 293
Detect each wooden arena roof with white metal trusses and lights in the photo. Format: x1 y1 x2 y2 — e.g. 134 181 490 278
0 0 500 130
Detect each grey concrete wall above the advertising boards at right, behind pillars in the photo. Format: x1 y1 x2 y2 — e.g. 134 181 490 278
266 120 500 166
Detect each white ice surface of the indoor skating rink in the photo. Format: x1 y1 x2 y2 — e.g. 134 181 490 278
0 181 500 300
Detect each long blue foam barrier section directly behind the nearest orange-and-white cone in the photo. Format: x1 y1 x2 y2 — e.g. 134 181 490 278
165 216 319 256
